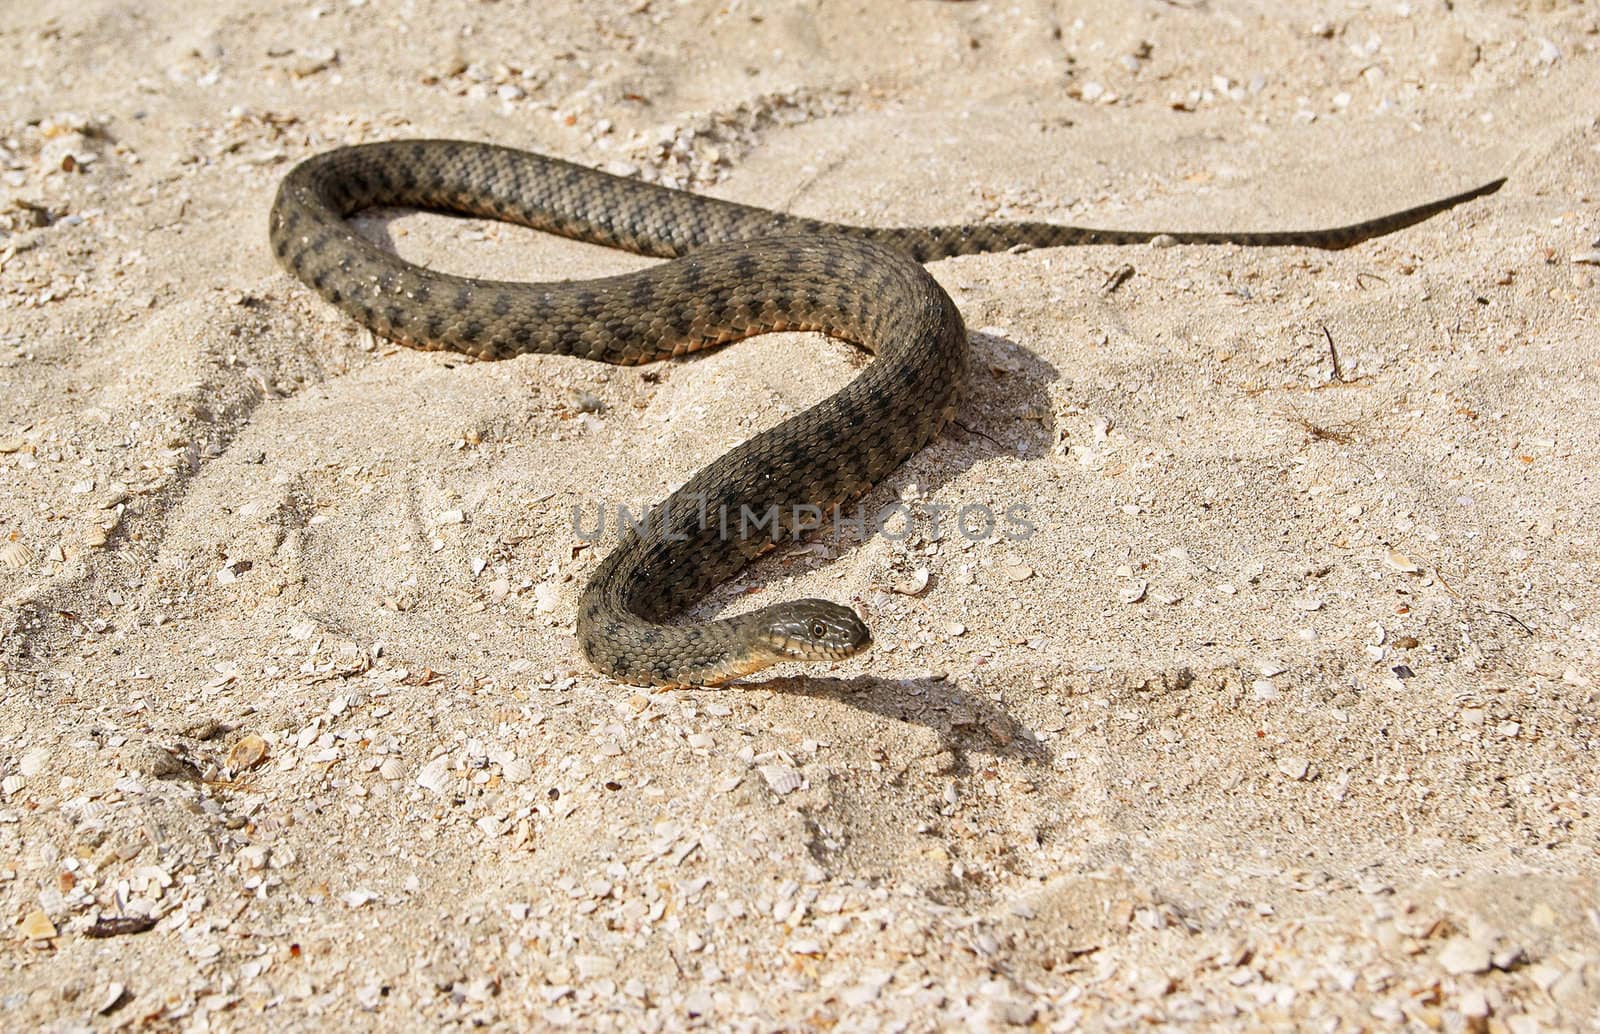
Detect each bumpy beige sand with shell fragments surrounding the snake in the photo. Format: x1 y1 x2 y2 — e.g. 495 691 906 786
0 0 1600 1034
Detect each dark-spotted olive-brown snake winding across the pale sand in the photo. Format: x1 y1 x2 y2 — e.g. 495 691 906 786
269 139 1504 687
